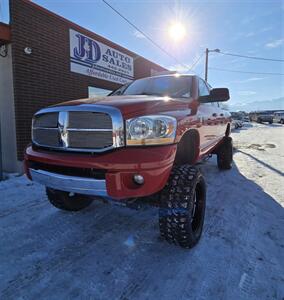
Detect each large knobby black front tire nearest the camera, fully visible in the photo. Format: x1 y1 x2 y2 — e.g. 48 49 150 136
159 165 206 248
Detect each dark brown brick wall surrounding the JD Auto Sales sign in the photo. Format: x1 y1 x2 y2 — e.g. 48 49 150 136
10 0 168 160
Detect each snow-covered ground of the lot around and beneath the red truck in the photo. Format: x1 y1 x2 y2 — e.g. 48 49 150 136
0 124 284 300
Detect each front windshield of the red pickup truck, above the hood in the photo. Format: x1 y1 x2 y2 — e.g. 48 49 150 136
110 76 192 98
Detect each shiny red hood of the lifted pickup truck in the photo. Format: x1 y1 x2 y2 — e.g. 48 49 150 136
53 95 190 118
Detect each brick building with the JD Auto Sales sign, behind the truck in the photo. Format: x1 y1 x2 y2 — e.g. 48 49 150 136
0 0 166 172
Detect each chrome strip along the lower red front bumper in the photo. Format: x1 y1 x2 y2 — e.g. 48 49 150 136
30 169 108 196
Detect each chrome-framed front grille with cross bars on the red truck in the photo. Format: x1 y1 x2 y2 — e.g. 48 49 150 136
32 105 124 152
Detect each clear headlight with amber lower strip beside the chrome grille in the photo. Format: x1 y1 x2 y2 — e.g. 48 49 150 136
126 115 177 146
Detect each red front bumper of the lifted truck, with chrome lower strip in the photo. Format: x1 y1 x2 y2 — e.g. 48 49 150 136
25 144 177 199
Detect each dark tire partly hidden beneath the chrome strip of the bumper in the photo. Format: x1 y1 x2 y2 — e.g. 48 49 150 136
46 188 93 211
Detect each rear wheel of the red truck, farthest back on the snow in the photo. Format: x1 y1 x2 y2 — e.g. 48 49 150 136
216 136 233 170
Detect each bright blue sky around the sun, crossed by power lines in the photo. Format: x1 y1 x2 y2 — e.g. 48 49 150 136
0 0 284 108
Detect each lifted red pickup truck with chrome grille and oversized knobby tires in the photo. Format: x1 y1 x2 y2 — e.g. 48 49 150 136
25 75 232 248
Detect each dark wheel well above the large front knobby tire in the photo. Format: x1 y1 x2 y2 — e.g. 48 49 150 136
175 129 200 165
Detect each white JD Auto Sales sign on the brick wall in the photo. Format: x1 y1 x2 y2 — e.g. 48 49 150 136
70 29 134 84
